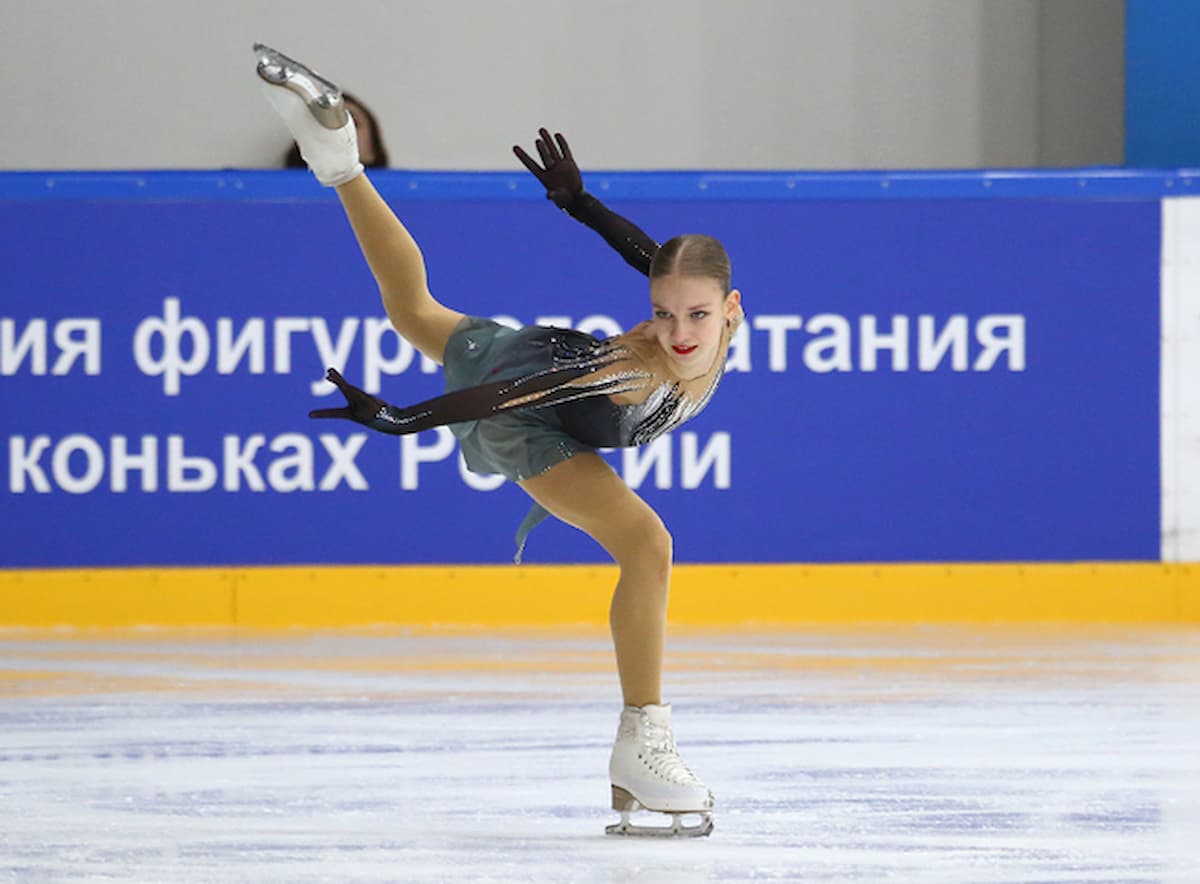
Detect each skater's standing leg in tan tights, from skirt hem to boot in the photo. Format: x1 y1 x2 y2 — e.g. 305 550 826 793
521 453 671 706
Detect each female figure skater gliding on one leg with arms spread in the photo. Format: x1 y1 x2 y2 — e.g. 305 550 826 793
254 44 742 835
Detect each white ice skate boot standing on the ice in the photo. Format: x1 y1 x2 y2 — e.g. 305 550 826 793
605 705 715 838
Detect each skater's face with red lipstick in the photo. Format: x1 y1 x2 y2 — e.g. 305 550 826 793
650 273 742 380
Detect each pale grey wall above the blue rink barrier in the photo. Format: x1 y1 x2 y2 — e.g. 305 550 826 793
0 0 1124 169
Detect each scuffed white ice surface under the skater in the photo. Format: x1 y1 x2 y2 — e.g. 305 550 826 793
0 629 1200 884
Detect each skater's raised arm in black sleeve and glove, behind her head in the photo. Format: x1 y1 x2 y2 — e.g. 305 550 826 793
512 128 659 276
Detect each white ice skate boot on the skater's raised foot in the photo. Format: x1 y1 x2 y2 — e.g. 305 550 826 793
254 43 362 187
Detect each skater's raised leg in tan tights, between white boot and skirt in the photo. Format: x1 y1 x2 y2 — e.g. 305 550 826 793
337 174 463 365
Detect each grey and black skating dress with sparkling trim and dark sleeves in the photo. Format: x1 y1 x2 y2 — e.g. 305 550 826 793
367 193 740 561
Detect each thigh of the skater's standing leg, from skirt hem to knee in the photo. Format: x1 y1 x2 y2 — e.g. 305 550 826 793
521 452 668 559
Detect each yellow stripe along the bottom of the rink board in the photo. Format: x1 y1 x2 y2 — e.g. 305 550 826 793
0 563 1200 629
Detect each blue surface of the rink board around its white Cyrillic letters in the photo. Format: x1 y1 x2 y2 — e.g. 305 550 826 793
0 172 1161 567
